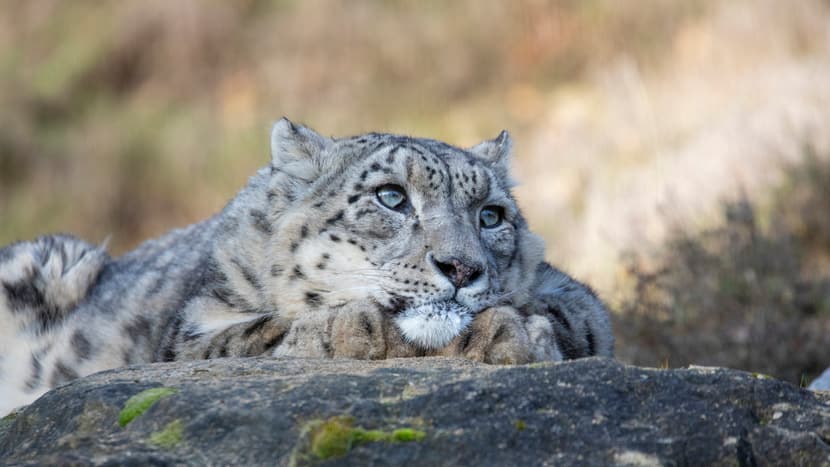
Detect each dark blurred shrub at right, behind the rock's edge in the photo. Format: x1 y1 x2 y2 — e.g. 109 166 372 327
616 147 830 384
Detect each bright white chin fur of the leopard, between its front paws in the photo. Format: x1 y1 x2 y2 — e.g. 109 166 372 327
395 302 472 349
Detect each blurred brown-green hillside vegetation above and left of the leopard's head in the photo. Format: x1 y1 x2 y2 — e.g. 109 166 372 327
0 0 702 252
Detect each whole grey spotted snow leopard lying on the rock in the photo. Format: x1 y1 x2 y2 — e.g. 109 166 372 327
0 118 613 413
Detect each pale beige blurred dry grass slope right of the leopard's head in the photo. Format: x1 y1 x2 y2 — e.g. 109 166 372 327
519 0 830 293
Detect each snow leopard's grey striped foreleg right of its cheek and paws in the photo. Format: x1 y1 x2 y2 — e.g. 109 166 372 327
523 263 614 360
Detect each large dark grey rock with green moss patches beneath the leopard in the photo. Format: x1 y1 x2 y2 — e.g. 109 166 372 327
0 358 830 466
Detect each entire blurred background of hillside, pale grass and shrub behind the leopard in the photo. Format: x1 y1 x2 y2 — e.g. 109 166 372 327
0 0 830 384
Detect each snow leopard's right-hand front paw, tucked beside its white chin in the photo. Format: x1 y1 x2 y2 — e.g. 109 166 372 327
439 306 535 365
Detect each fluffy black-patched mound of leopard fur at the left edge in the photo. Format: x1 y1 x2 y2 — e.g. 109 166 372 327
0 235 109 334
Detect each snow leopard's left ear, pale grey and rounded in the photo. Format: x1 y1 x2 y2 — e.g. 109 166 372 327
271 117 333 182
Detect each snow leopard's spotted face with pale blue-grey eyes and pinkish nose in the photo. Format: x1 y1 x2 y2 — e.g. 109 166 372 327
266 119 541 348
